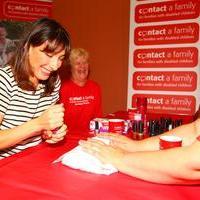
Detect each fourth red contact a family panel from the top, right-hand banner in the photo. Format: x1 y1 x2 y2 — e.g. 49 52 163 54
133 71 197 91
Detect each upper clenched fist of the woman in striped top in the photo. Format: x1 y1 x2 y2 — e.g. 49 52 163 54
37 104 64 130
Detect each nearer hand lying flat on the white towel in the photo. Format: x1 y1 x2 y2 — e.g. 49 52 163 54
79 139 125 168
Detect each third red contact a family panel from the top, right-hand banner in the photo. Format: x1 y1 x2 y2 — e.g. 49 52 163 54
133 47 198 68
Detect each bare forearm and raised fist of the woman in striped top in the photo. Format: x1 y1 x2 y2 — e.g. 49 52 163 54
0 105 66 149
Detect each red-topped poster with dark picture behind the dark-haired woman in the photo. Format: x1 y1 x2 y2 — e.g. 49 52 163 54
0 0 52 67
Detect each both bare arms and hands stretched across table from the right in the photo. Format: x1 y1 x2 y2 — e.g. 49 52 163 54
80 119 200 184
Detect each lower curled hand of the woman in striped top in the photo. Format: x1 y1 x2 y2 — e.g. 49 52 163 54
42 124 67 144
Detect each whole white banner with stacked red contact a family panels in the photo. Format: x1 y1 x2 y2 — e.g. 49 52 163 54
127 0 200 115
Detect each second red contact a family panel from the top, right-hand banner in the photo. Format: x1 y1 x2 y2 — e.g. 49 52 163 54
134 23 199 45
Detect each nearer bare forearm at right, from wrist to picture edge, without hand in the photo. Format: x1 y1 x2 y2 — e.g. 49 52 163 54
117 147 200 184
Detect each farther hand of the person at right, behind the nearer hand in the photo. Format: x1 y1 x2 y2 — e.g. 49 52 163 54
98 133 136 152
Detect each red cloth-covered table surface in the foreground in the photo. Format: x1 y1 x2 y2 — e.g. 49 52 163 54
0 136 200 200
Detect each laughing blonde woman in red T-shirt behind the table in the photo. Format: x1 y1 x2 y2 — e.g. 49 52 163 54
60 48 102 135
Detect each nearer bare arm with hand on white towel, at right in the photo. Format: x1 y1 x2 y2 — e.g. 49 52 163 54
80 140 200 184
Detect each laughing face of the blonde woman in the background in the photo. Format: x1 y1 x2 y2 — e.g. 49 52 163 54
71 56 89 85
